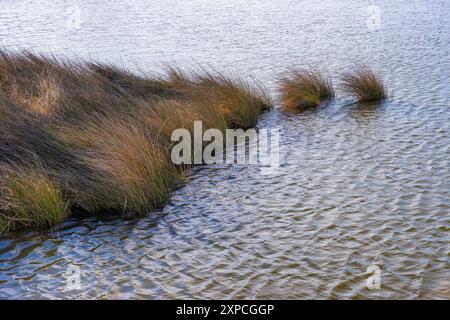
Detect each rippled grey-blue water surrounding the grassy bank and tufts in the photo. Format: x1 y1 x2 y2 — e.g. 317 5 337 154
0 0 450 299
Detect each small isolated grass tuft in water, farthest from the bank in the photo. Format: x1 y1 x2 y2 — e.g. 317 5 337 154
342 66 387 102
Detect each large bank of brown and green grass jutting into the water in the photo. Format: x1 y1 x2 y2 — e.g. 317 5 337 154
0 51 273 234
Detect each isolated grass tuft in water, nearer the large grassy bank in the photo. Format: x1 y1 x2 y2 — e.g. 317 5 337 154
280 69 334 111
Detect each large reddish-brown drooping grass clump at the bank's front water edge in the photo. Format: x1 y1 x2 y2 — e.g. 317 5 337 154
59 118 179 214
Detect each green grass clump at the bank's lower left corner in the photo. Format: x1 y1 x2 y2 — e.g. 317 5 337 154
0 166 69 233
